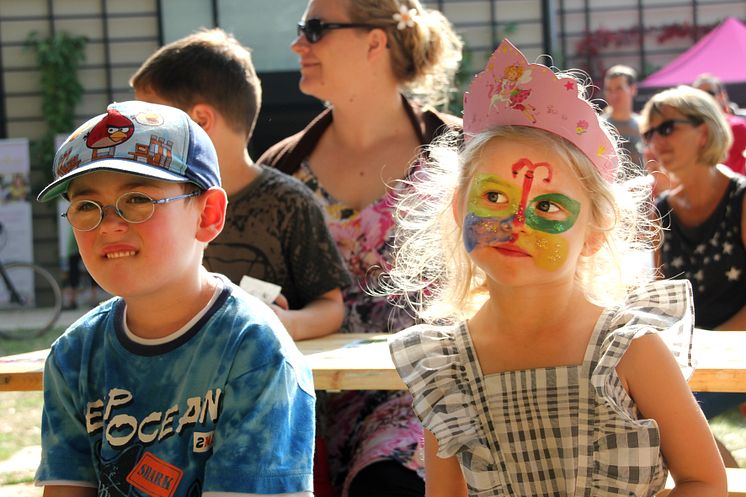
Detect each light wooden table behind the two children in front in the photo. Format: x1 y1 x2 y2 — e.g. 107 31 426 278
0 330 746 392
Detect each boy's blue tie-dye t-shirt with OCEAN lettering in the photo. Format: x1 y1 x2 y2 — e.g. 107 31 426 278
36 278 315 497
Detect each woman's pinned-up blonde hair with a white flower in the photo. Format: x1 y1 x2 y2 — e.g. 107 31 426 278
347 0 463 105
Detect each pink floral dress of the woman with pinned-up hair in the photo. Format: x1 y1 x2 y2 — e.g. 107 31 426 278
294 161 423 497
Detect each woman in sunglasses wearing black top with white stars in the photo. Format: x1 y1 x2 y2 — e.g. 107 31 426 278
641 86 746 466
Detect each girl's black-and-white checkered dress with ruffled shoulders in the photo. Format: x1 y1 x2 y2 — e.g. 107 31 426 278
390 280 693 497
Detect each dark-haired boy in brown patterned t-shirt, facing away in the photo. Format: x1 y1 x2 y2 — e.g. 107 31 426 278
130 29 350 340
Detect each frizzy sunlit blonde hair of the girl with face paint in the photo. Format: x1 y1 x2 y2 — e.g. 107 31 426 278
384 121 657 322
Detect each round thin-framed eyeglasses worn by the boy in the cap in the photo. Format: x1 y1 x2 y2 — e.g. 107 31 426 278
62 190 202 231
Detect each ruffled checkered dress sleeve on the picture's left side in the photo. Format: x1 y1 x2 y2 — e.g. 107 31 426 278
389 324 486 457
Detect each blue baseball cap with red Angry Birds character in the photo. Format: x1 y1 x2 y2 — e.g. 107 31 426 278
37 100 220 202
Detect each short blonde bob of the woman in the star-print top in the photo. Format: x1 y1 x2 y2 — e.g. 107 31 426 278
640 85 733 166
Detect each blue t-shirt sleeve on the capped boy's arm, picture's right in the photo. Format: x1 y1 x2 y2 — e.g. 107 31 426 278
204 350 315 494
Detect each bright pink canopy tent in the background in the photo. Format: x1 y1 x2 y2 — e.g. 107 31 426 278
638 17 746 88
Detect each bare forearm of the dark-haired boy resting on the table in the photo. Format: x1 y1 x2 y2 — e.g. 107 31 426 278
272 288 345 340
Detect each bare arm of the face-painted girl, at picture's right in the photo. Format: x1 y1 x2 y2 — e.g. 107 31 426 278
617 334 727 497
